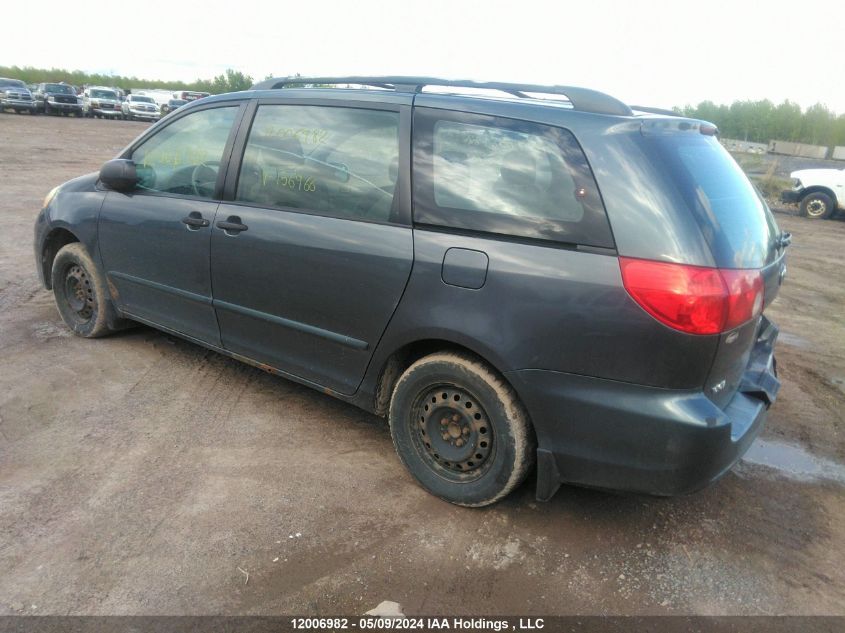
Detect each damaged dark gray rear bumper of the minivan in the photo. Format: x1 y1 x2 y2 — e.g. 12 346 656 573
507 318 780 500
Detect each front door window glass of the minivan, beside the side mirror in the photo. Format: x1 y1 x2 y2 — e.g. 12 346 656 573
132 106 238 198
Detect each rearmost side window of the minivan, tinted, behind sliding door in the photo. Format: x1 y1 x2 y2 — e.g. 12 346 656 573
414 108 613 247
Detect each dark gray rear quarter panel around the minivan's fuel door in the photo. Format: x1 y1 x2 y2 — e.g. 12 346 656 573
379 229 717 388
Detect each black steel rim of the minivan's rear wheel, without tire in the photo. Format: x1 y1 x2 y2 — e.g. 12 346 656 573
410 385 496 483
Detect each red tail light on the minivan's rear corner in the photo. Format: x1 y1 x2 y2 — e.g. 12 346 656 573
619 257 763 334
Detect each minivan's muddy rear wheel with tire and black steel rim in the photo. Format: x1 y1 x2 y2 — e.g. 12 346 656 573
389 352 535 507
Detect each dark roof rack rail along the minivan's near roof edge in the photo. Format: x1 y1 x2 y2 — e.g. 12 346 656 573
252 76 632 116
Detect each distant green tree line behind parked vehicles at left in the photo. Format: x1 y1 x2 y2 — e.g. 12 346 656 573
0 66 254 94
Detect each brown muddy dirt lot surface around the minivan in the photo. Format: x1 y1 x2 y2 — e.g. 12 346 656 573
0 114 845 615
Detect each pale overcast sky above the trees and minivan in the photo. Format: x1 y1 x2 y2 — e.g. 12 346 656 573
6 0 845 113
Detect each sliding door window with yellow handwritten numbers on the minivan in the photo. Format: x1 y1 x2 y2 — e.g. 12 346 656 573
236 105 399 222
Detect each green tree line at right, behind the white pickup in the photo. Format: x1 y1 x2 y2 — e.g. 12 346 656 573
675 99 845 147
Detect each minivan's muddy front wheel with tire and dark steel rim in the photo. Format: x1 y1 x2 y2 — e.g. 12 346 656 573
51 242 115 338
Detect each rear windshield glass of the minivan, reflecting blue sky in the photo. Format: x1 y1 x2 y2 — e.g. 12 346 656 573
644 132 779 268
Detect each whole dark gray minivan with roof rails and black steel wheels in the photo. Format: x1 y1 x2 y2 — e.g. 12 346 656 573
35 77 789 506
